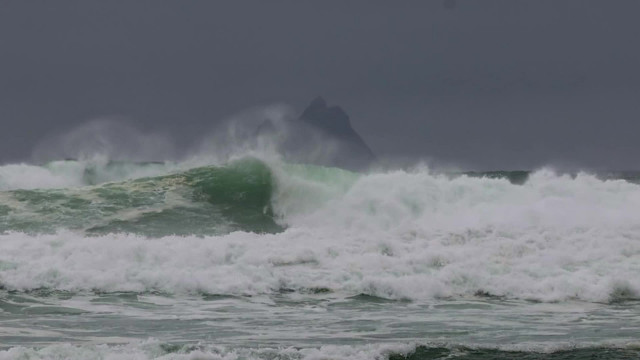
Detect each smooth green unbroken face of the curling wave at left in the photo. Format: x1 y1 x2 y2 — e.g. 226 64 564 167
0 159 282 237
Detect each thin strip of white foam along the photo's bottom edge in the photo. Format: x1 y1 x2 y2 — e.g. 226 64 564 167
0 339 637 360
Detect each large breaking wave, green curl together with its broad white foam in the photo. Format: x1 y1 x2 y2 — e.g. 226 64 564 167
0 159 640 302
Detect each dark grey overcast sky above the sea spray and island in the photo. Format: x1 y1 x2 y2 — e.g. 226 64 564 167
0 0 640 169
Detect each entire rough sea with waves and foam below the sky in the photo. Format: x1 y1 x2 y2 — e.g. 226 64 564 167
0 158 640 359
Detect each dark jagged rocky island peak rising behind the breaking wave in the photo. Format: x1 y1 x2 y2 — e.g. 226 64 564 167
256 97 375 170
